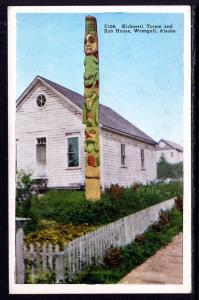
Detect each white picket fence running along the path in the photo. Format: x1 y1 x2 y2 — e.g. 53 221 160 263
16 198 175 283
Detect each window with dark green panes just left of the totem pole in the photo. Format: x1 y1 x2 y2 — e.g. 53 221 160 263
67 137 79 167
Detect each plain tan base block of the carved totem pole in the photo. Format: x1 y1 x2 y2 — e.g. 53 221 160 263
85 166 100 200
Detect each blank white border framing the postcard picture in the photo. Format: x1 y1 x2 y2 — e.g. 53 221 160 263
8 6 191 294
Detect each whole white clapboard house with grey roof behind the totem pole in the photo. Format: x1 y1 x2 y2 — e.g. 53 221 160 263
16 76 157 188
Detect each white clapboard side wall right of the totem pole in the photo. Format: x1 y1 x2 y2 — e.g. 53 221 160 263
102 130 156 186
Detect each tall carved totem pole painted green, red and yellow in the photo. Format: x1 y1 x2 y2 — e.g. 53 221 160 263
82 16 100 200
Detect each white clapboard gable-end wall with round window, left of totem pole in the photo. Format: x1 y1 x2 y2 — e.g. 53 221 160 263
16 84 85 187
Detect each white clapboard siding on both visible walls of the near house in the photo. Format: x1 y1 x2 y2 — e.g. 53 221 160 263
16 83 156 187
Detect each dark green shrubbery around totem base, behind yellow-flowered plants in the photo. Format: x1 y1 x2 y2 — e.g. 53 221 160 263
17 182 182 232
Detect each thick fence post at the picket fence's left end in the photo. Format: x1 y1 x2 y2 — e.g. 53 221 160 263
15 228 25 283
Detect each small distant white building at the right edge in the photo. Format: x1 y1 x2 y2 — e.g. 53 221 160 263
156 139 183 164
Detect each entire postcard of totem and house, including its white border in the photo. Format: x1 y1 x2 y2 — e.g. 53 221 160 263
8 6 191 294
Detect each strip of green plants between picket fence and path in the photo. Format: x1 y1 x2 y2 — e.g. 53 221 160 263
27 201 182 284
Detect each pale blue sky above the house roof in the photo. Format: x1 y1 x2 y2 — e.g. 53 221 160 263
16 11 184 144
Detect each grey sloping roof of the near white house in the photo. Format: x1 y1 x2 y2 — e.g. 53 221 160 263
17 76 157 144
